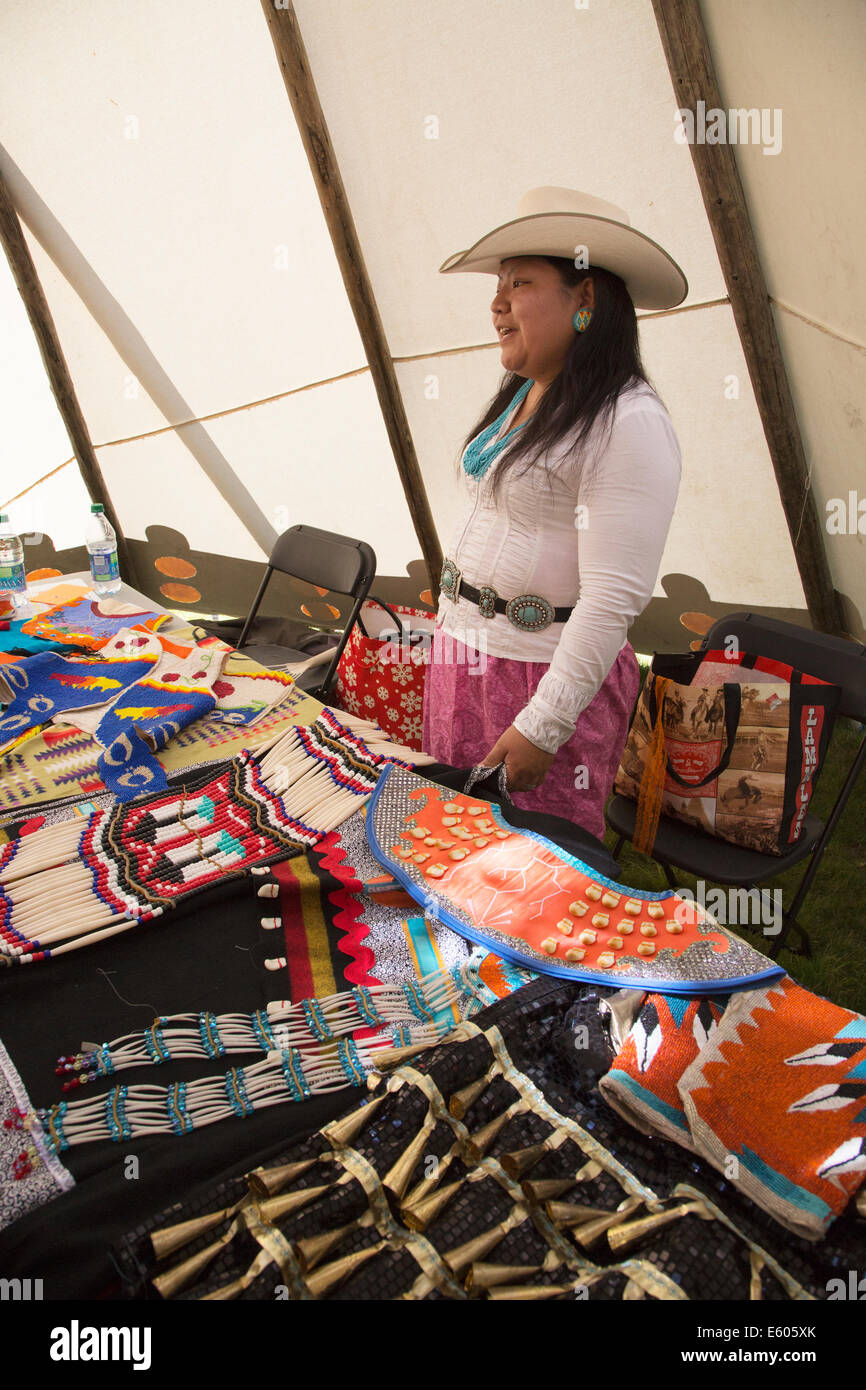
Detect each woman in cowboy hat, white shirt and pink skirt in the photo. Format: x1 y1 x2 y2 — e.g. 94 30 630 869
424 188 688 838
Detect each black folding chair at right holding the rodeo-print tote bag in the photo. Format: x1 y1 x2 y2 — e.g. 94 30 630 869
605 613 866 955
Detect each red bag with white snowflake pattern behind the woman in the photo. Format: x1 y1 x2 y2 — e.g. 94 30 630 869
334 599 435 751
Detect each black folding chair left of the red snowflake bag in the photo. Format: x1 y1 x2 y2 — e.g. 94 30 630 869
236 525 375 701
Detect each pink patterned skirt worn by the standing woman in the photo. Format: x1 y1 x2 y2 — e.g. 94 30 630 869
421 627 639 840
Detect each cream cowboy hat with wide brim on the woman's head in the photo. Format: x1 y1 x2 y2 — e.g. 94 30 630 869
439 188 688 309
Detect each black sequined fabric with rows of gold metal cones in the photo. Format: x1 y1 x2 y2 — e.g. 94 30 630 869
115 979 866 1301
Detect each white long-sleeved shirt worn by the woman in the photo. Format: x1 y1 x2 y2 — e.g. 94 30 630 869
438 382 681 753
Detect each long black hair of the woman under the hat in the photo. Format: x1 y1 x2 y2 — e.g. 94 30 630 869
463 256 649 495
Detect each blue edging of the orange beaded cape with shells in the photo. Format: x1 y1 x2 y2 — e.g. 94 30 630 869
364 767 785 995
